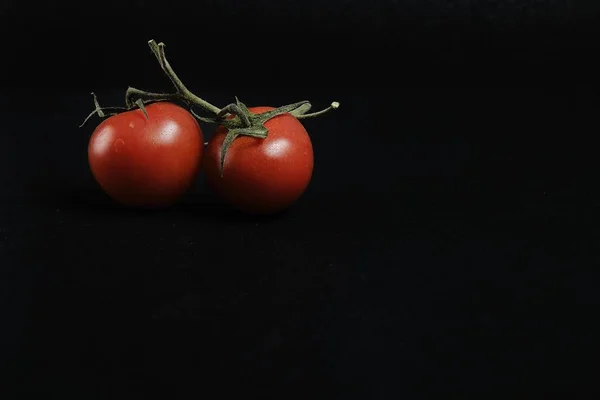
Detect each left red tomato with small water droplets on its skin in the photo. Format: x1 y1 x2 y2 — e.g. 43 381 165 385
88 102 204 208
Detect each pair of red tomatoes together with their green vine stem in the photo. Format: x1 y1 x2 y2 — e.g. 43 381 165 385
84 40 339 214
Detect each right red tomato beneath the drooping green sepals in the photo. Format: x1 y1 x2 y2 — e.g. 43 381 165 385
203 107 314 214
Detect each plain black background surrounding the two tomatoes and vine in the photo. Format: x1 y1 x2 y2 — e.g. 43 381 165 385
0 0 600 399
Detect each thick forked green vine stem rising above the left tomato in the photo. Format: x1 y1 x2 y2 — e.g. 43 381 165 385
125 40 221 114
